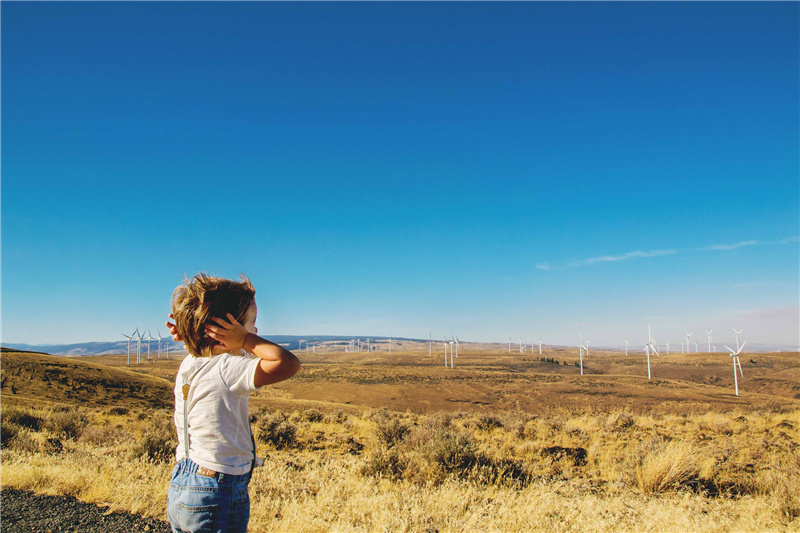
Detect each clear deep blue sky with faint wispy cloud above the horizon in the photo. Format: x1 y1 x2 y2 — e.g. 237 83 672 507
0 2 800 350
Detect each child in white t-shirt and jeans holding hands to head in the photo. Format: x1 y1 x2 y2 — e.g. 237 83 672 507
167 273 300 533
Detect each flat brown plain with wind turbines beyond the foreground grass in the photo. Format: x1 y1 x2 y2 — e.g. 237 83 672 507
84 345 800 414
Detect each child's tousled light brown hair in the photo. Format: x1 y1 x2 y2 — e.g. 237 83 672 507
172 272 256 357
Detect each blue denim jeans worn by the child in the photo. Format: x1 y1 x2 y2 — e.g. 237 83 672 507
167 459 252 533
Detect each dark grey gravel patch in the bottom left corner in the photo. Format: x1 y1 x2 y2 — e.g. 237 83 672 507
0 489 170 533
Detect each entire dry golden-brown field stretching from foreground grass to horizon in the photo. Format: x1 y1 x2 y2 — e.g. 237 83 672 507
0 349 800 533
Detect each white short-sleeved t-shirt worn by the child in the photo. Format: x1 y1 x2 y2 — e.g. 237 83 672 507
175 353 260 475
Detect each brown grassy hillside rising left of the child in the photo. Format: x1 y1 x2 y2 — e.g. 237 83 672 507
0 352 173 408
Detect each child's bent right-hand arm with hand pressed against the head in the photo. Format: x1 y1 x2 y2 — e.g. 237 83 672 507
206 313 300 387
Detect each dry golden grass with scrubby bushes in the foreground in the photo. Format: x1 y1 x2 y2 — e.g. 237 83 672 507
0 407 800 533
